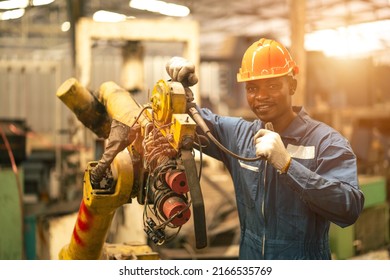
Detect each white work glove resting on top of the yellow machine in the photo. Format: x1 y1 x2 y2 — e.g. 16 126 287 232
165 56 198 87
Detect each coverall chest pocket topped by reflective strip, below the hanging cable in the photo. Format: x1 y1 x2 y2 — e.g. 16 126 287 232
236 161 263 208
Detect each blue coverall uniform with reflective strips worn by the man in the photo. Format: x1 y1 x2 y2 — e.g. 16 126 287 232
199 107 364 260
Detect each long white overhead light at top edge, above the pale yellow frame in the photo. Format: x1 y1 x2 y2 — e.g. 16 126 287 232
129 0 190 17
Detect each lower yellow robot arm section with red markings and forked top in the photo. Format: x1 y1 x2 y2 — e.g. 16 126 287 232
59 150 136 260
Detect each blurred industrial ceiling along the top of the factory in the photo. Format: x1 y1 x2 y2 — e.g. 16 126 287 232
0 0 390 59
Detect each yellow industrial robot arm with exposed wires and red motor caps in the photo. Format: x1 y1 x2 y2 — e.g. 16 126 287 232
57 78 207 259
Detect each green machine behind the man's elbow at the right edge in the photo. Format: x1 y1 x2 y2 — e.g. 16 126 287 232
329 175 390 260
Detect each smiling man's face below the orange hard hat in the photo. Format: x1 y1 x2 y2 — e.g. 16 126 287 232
245 76 294 122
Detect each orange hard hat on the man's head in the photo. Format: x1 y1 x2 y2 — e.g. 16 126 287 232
237 38 298 82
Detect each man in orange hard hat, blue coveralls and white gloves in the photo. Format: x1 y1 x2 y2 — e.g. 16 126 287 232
167 38 364 259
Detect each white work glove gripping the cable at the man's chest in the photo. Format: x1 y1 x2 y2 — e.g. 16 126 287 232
254 129 291 173
